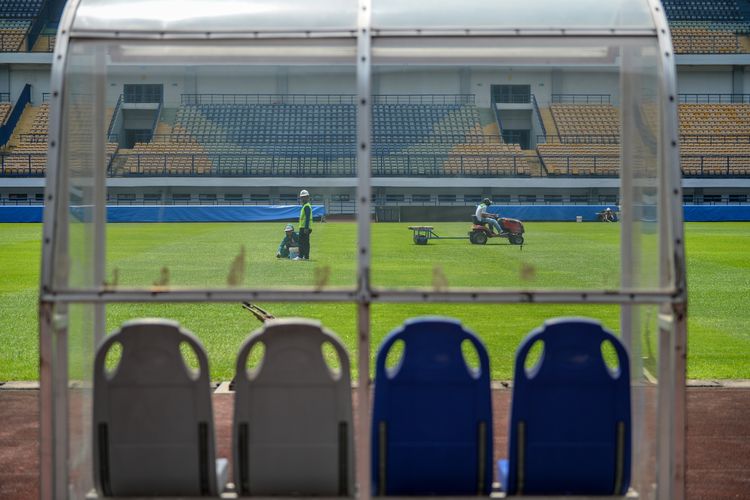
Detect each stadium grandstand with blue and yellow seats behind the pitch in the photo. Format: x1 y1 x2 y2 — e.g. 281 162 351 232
0 0 750 214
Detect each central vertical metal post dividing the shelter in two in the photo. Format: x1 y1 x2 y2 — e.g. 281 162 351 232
356 0 372 500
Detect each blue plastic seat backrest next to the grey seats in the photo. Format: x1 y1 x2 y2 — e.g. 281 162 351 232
372 317 492 495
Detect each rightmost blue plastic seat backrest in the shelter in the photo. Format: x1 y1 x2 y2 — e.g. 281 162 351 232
507 318 631 495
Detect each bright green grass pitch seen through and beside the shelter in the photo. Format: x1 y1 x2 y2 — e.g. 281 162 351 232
0 223 750 381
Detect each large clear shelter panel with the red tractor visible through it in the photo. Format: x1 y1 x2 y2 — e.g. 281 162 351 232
372 38 660 291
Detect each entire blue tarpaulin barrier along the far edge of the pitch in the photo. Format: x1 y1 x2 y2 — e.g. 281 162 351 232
0 205 750 222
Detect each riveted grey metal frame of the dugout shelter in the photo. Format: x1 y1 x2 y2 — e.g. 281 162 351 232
39 0 687 500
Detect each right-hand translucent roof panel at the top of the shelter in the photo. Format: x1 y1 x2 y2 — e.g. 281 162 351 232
372 0 653 31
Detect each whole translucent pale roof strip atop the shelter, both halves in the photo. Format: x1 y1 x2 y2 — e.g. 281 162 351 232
73 0 654 35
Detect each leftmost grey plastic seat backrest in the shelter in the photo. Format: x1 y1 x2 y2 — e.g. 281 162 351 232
92 319 220 496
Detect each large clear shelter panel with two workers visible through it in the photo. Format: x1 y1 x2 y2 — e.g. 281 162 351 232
63 40 356 289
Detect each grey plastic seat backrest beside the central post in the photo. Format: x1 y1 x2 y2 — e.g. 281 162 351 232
233 319 354 496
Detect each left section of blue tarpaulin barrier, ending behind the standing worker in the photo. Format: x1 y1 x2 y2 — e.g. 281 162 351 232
0 205 326 222
